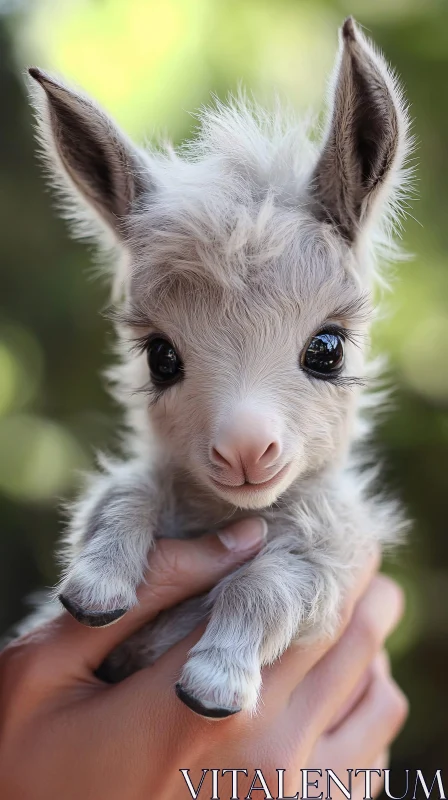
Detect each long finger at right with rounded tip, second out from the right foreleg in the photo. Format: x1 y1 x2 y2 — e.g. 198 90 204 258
290 575 403 736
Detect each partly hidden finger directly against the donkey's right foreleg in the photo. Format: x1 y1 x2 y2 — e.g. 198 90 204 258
263 550 380 706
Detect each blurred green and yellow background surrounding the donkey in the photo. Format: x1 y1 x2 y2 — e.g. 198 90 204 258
0 0 448 776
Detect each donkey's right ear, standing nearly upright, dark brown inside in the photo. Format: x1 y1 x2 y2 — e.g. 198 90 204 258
312 17 409 242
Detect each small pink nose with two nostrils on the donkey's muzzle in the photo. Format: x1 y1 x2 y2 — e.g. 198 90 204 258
211 414 282 482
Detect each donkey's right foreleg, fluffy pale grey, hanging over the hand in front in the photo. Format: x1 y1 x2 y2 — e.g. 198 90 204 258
177 539 342 718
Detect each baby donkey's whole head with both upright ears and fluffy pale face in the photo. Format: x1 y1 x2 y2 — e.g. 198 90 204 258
30 19 408 508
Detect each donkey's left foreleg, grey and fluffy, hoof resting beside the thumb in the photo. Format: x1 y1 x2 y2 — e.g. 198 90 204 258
58 464 154 627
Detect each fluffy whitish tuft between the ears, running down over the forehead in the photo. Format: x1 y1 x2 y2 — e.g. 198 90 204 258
125 96 380 314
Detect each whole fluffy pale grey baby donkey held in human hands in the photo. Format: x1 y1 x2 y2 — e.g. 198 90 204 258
26 18 410 717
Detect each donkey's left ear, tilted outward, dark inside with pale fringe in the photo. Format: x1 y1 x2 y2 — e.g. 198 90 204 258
29 67 150 238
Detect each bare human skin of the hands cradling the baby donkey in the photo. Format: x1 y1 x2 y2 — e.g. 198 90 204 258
0 519 407 800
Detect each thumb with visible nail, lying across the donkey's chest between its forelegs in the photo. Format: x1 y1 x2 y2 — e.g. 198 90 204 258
21 517 266 674
